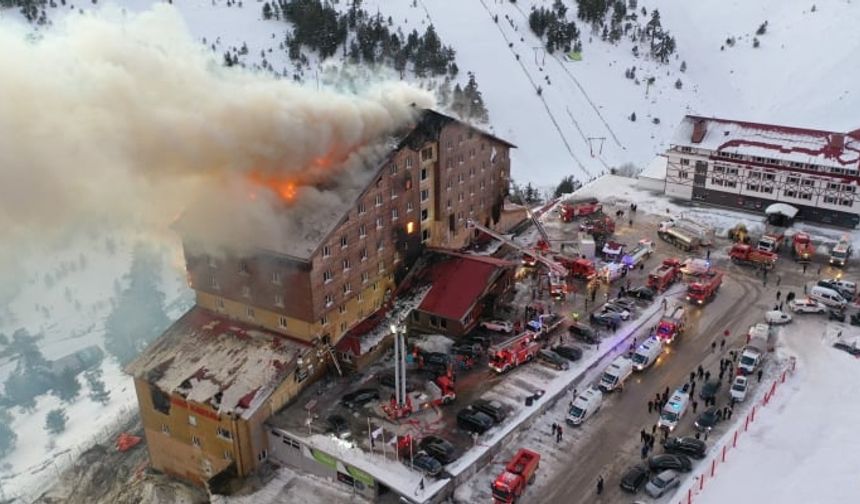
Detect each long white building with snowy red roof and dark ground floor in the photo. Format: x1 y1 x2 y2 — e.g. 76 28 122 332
665 116 860 228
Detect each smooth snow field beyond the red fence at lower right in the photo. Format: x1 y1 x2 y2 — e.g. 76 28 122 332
671 317 860 504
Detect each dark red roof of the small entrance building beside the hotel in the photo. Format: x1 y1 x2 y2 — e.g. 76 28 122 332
418 255 510 320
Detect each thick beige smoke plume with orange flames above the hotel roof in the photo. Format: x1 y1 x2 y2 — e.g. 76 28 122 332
0 5 433 274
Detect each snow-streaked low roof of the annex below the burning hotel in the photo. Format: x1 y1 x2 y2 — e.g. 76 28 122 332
126 307 310 418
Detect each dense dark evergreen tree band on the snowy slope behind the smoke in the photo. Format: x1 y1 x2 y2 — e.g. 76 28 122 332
262 0 459 77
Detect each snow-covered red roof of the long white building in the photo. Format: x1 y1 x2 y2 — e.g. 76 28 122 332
670 115 860 170
